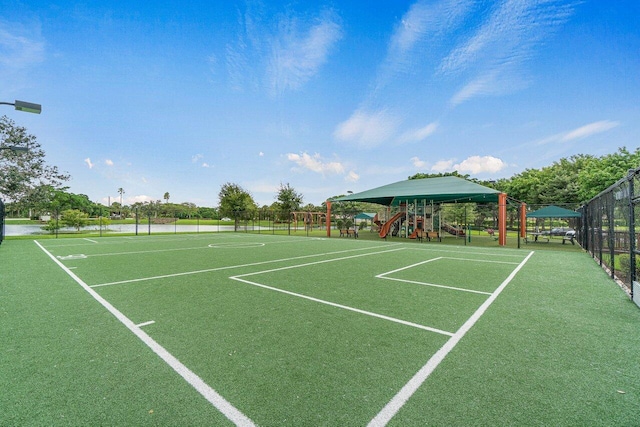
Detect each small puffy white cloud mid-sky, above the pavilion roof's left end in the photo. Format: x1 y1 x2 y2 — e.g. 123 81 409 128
333 110 400 148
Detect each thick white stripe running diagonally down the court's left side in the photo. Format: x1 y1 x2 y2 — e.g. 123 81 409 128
34 240 255 426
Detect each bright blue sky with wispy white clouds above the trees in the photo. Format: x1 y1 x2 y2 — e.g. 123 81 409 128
0 0 640 206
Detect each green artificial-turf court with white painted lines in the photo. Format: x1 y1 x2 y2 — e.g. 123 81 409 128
0 233 640 426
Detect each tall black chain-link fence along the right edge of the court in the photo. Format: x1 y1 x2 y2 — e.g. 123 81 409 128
580 168 640 305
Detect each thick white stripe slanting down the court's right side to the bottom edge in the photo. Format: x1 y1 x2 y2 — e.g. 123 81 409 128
368 251 534 427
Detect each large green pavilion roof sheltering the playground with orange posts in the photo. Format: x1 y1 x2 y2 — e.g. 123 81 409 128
333 176 500 206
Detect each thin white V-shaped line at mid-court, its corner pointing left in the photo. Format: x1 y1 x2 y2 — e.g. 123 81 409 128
229 248 453 336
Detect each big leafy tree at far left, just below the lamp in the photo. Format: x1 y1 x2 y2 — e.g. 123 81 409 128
0 116 69 206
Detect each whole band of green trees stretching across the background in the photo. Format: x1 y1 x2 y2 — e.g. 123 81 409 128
0 116 640 221
